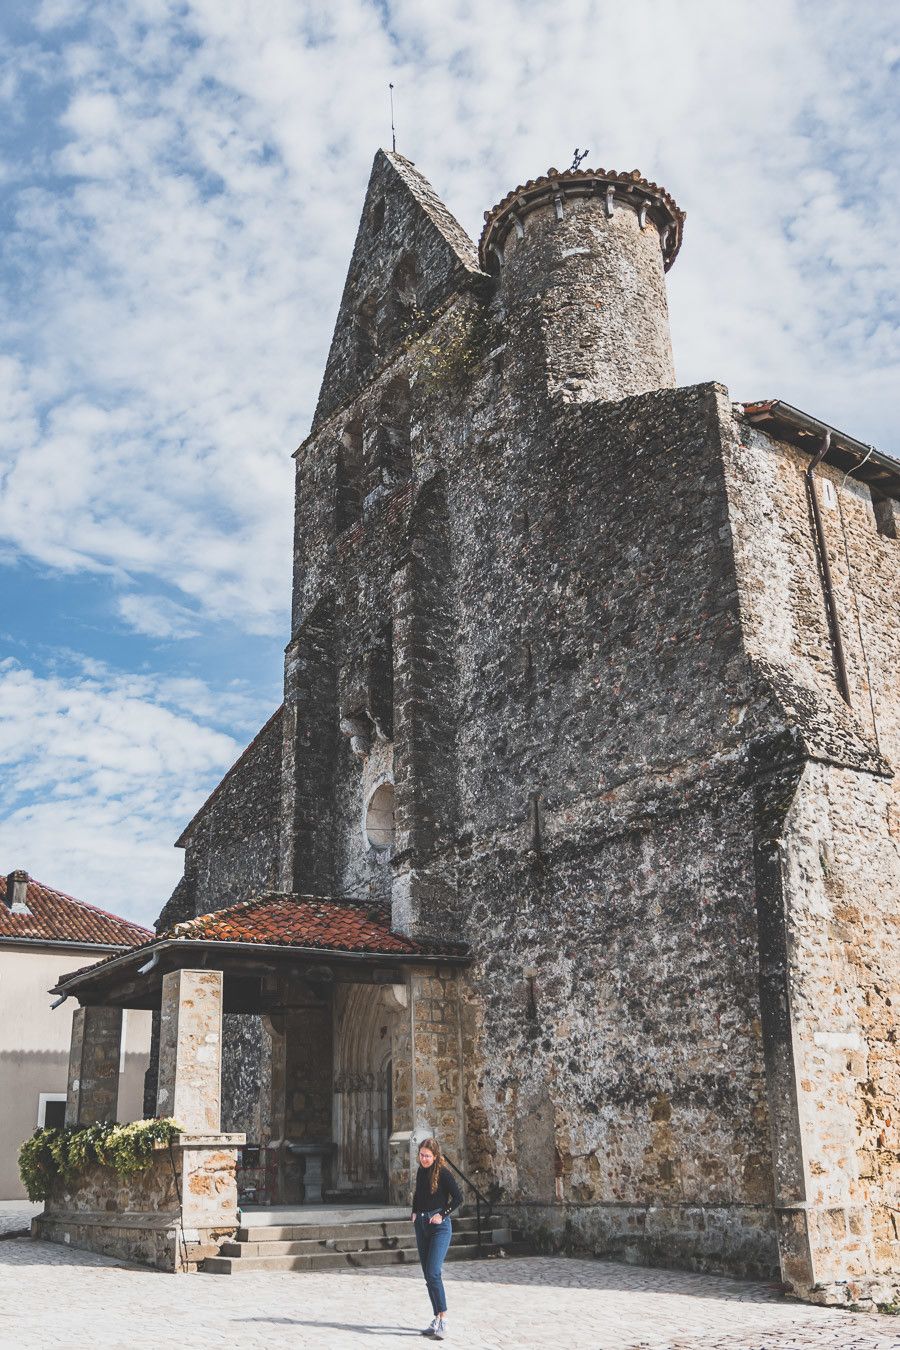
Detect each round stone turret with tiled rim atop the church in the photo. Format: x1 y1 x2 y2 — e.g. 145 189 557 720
479 169 684 402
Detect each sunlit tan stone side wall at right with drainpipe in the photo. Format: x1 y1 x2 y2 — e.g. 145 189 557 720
725 419 900 1301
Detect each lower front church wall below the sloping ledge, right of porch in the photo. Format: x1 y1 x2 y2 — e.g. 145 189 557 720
464 786 777 1273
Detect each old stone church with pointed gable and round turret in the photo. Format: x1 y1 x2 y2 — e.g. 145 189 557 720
50 151 900 1301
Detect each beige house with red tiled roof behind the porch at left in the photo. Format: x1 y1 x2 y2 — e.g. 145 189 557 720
0 872 151 1200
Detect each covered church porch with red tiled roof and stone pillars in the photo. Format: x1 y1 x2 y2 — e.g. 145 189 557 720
35 894 467 1269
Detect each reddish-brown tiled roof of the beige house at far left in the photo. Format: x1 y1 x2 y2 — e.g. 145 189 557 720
0 876 152 948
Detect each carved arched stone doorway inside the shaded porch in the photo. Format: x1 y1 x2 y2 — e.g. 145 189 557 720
333 984 394 1197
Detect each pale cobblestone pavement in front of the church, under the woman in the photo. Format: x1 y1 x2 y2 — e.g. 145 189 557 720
0 1238 900 1350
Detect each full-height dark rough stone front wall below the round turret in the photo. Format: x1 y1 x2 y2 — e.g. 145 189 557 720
449 386 777 1272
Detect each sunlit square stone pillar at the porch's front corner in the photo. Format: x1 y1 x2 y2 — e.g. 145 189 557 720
157 971 223 1134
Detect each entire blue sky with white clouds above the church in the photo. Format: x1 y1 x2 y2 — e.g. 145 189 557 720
0 0 900 921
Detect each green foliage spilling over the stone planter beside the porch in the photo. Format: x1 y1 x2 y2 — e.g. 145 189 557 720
19 1119 184 1200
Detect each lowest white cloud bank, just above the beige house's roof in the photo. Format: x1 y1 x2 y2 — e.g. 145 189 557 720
0 660 269 923
